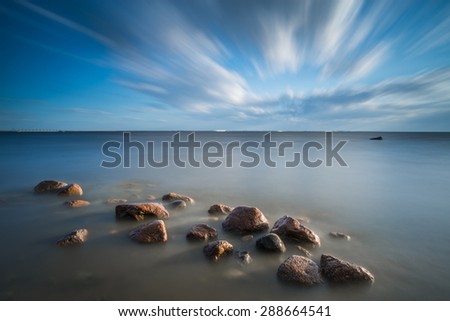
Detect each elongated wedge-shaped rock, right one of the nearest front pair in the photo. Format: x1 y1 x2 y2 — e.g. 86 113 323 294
320 254 375 283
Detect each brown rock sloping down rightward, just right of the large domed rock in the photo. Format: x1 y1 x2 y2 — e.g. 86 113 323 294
270 215 320 246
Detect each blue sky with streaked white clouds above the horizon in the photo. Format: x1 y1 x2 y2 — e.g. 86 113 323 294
0 0 450 131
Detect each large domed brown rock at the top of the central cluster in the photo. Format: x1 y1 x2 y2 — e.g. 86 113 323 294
222 206 269 233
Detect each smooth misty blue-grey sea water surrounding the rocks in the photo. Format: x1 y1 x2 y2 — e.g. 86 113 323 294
0 132 450 300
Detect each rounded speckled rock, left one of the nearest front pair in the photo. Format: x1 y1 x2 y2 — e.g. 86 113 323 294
277 255 323 286
